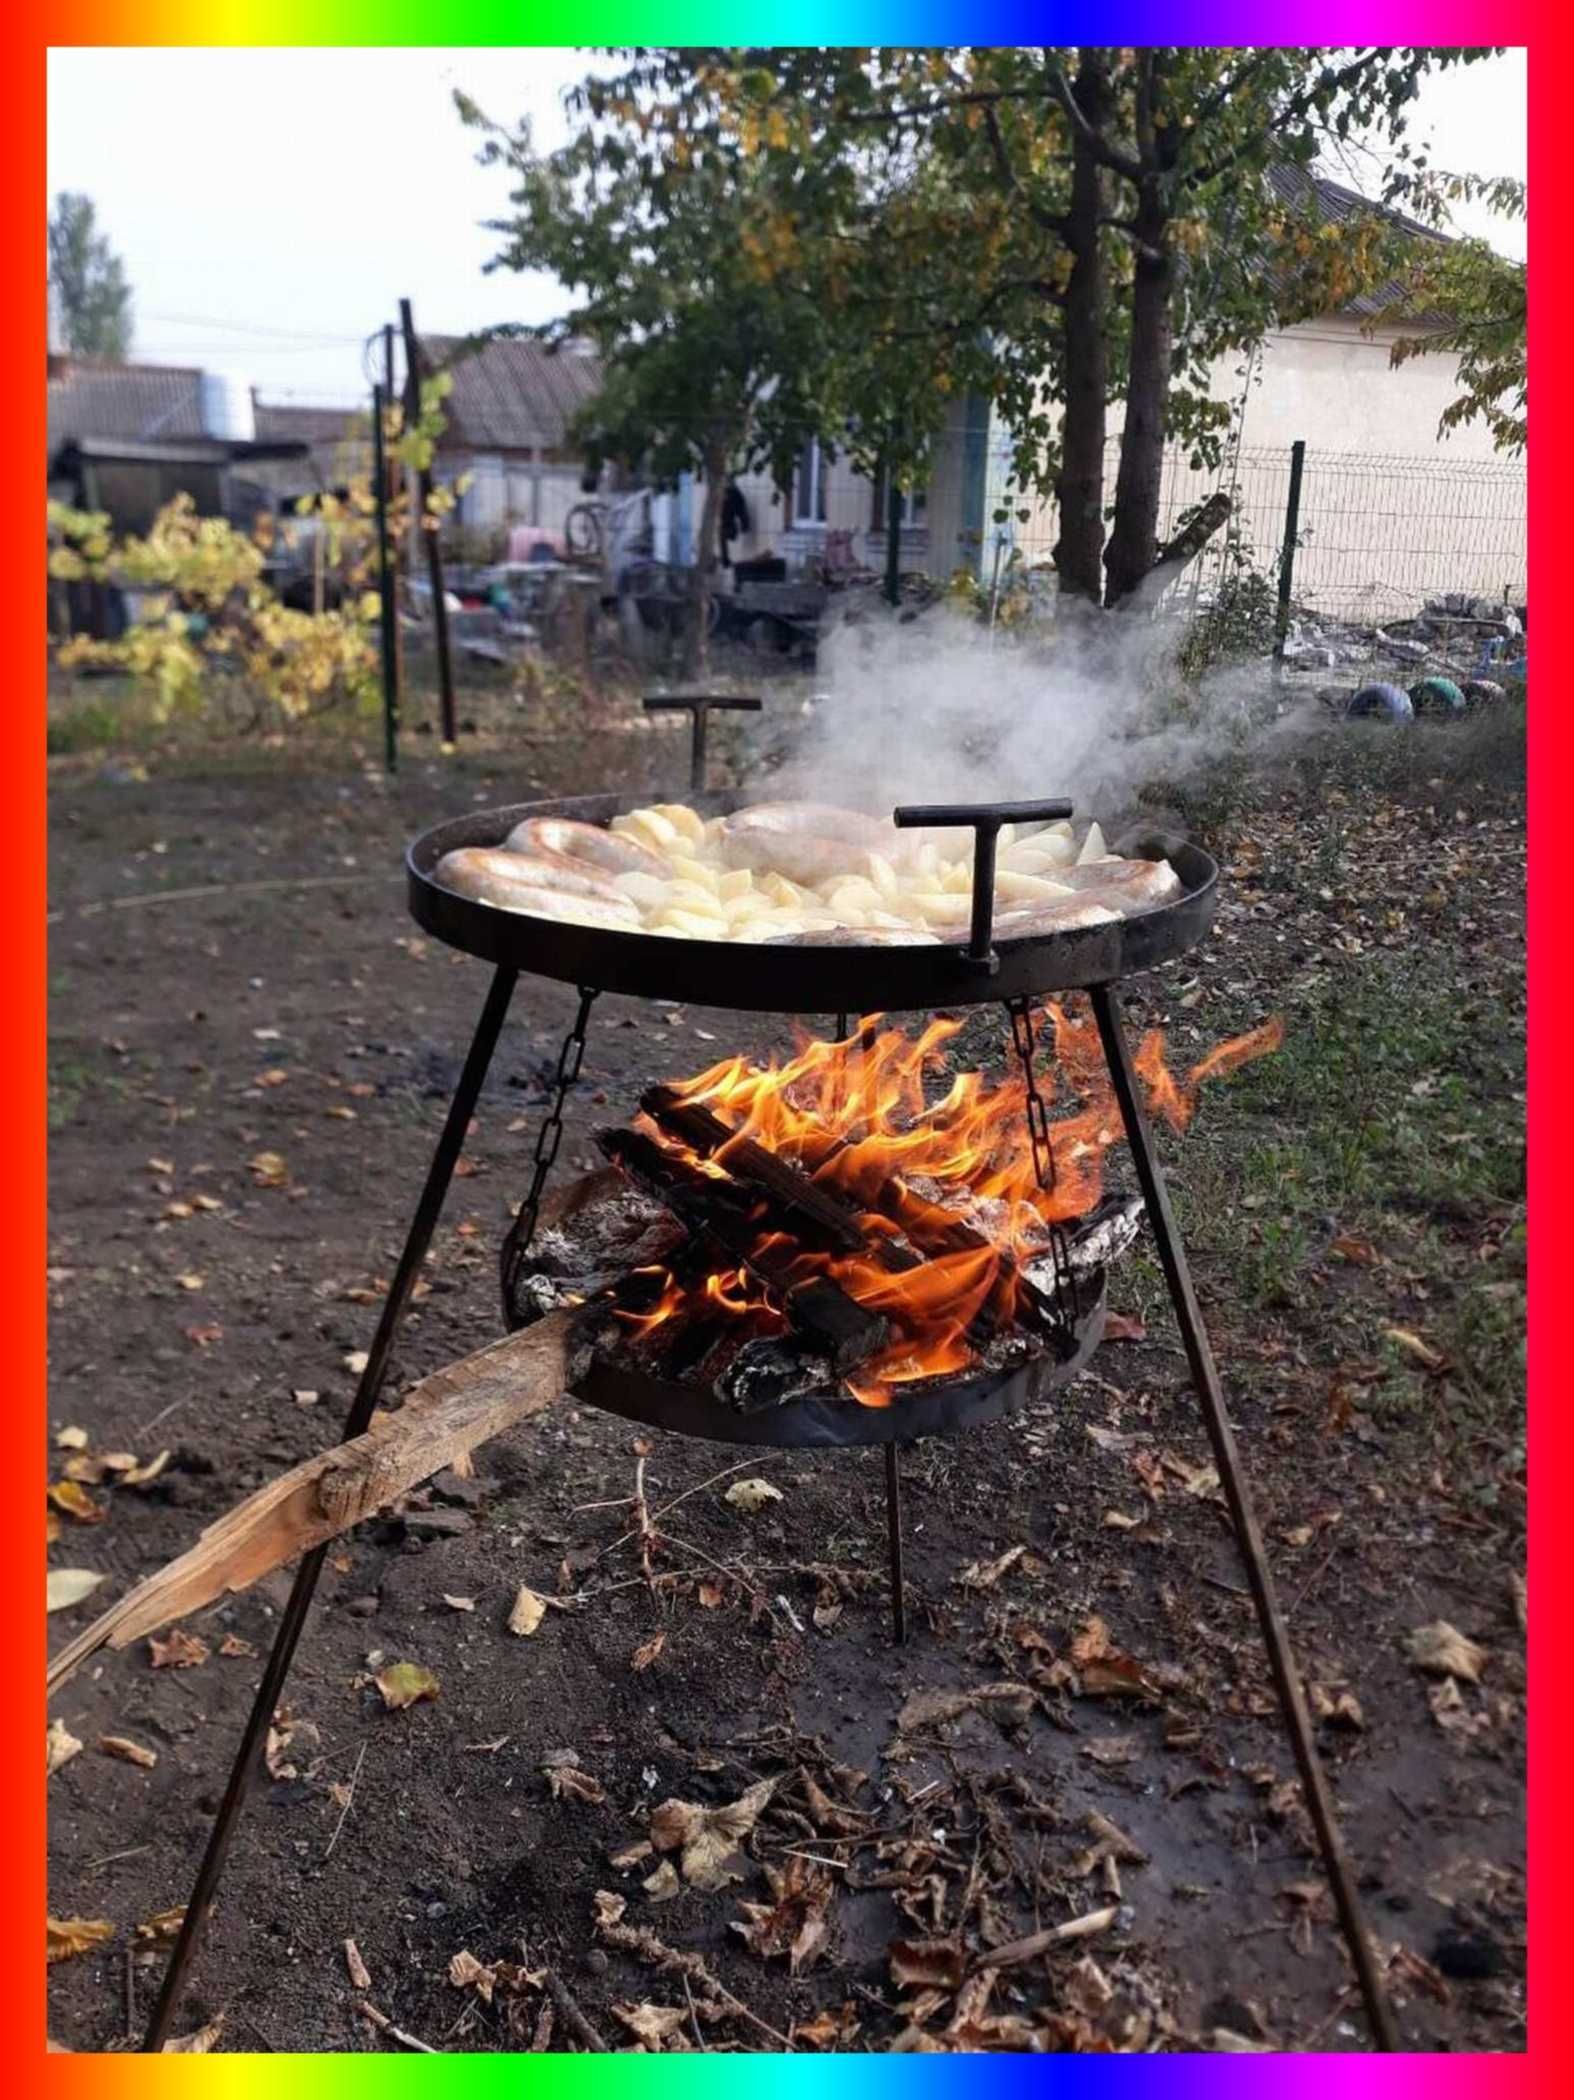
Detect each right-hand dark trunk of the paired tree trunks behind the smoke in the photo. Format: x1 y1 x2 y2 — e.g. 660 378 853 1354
1104 53 1175 605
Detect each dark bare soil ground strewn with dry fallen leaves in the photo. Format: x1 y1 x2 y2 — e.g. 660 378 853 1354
48 684 1524 2050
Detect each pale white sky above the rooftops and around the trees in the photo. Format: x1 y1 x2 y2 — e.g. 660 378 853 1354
48 48 1526 403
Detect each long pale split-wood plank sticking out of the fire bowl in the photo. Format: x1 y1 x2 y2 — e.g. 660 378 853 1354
46 1306 575 1697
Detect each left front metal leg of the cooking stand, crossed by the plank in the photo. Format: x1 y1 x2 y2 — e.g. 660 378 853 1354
143 965 518 2054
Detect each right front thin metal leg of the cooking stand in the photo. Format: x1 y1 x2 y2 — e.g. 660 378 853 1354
1089 985 1400 2050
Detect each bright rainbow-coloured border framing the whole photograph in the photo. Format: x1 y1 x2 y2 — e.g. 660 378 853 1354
18 12 1574 2100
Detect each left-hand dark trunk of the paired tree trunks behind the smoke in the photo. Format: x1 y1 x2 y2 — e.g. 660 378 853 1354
1054 50 1110 605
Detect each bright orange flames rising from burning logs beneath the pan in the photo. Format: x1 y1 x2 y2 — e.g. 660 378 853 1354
619 1006 1284 1407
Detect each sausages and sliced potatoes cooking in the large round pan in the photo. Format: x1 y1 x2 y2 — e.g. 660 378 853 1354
437 802 1182 947
